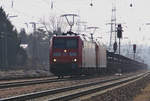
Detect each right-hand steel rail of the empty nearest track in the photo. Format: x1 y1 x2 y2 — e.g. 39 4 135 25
48 74 149 101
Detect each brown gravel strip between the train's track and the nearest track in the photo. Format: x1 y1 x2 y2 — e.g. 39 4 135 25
0 70 146 98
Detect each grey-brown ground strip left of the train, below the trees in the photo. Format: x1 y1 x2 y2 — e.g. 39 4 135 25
0 70 52 83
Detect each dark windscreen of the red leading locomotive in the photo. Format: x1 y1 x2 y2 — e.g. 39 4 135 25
53 38 78 49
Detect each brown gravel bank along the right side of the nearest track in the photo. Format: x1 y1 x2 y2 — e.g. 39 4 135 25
82 72 150 101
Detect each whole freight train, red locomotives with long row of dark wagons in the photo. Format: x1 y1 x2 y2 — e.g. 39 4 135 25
49 35 146 77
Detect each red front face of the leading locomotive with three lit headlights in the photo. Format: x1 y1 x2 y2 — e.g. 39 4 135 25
50 36 82 76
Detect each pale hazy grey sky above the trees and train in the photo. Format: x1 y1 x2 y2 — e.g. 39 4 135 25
0 0 150 44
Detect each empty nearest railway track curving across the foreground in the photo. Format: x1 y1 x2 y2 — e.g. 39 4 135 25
0 72 149 101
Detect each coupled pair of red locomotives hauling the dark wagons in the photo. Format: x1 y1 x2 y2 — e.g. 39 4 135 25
50 35 106 76
